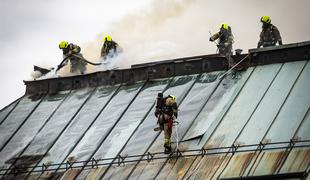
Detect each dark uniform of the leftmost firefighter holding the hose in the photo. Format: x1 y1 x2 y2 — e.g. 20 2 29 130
62 43 87 74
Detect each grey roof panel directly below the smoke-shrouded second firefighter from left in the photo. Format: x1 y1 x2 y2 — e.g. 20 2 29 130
34 86 119 173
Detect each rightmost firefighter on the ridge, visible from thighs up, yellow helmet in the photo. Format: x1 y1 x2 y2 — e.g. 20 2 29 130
257 16 282 48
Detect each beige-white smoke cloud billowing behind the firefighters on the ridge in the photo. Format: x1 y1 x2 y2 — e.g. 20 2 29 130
32 0 309 76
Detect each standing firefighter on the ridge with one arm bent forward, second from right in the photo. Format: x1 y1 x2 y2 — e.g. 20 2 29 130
209 23 235 67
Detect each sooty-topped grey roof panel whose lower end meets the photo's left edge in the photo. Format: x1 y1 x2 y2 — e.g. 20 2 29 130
0 91 69 166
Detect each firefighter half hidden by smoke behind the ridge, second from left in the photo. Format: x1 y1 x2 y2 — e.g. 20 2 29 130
100 36 120 59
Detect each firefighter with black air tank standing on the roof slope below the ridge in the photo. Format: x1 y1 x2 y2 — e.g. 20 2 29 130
155 93 178 154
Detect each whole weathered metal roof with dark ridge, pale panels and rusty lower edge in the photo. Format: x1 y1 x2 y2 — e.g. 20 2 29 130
0 42 310 179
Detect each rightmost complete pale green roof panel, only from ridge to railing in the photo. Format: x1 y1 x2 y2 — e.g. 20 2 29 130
236 61 305 148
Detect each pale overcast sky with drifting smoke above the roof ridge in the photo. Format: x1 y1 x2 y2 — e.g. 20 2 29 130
0 0 310 109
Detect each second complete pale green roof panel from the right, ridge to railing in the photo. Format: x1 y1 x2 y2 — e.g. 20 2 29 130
205 64 281 147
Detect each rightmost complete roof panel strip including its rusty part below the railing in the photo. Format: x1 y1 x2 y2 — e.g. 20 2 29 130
221 62 305 178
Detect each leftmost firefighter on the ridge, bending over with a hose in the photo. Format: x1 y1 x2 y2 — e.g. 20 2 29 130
57 41 87 74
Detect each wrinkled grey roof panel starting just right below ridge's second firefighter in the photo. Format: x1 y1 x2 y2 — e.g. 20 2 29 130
64 82 144 161
